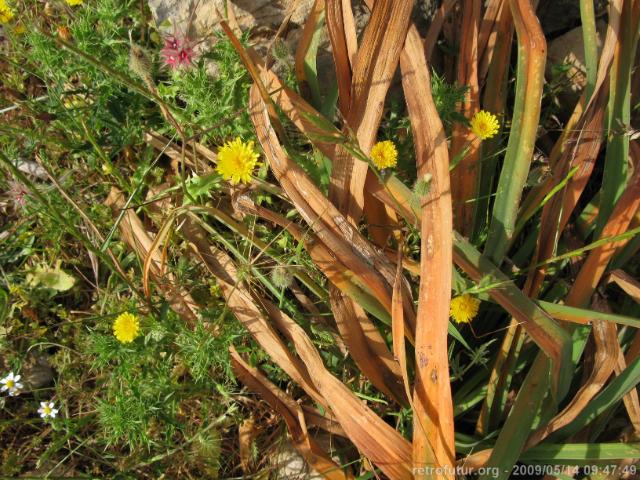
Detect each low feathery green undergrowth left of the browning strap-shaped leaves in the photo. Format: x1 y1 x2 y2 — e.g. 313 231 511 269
0 0 272 476
